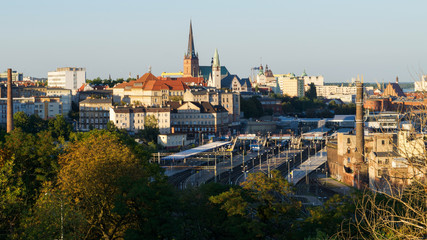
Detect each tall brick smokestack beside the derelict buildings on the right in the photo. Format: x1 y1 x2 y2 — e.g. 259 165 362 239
355 77 365 188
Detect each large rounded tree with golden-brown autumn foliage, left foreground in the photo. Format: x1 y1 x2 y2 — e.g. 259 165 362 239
58 131 150 239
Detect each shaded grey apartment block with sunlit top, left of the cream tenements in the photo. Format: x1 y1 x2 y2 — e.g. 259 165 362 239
78 99 113 131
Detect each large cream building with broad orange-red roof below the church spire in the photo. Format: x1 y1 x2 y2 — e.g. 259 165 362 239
113 73 190 107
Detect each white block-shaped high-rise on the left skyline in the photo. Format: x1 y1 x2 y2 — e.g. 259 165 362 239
47 67 86 92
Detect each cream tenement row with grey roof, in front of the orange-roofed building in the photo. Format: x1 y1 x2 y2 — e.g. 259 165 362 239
110 106 171 134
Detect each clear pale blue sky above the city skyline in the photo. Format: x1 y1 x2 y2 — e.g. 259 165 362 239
0 0 427 82
